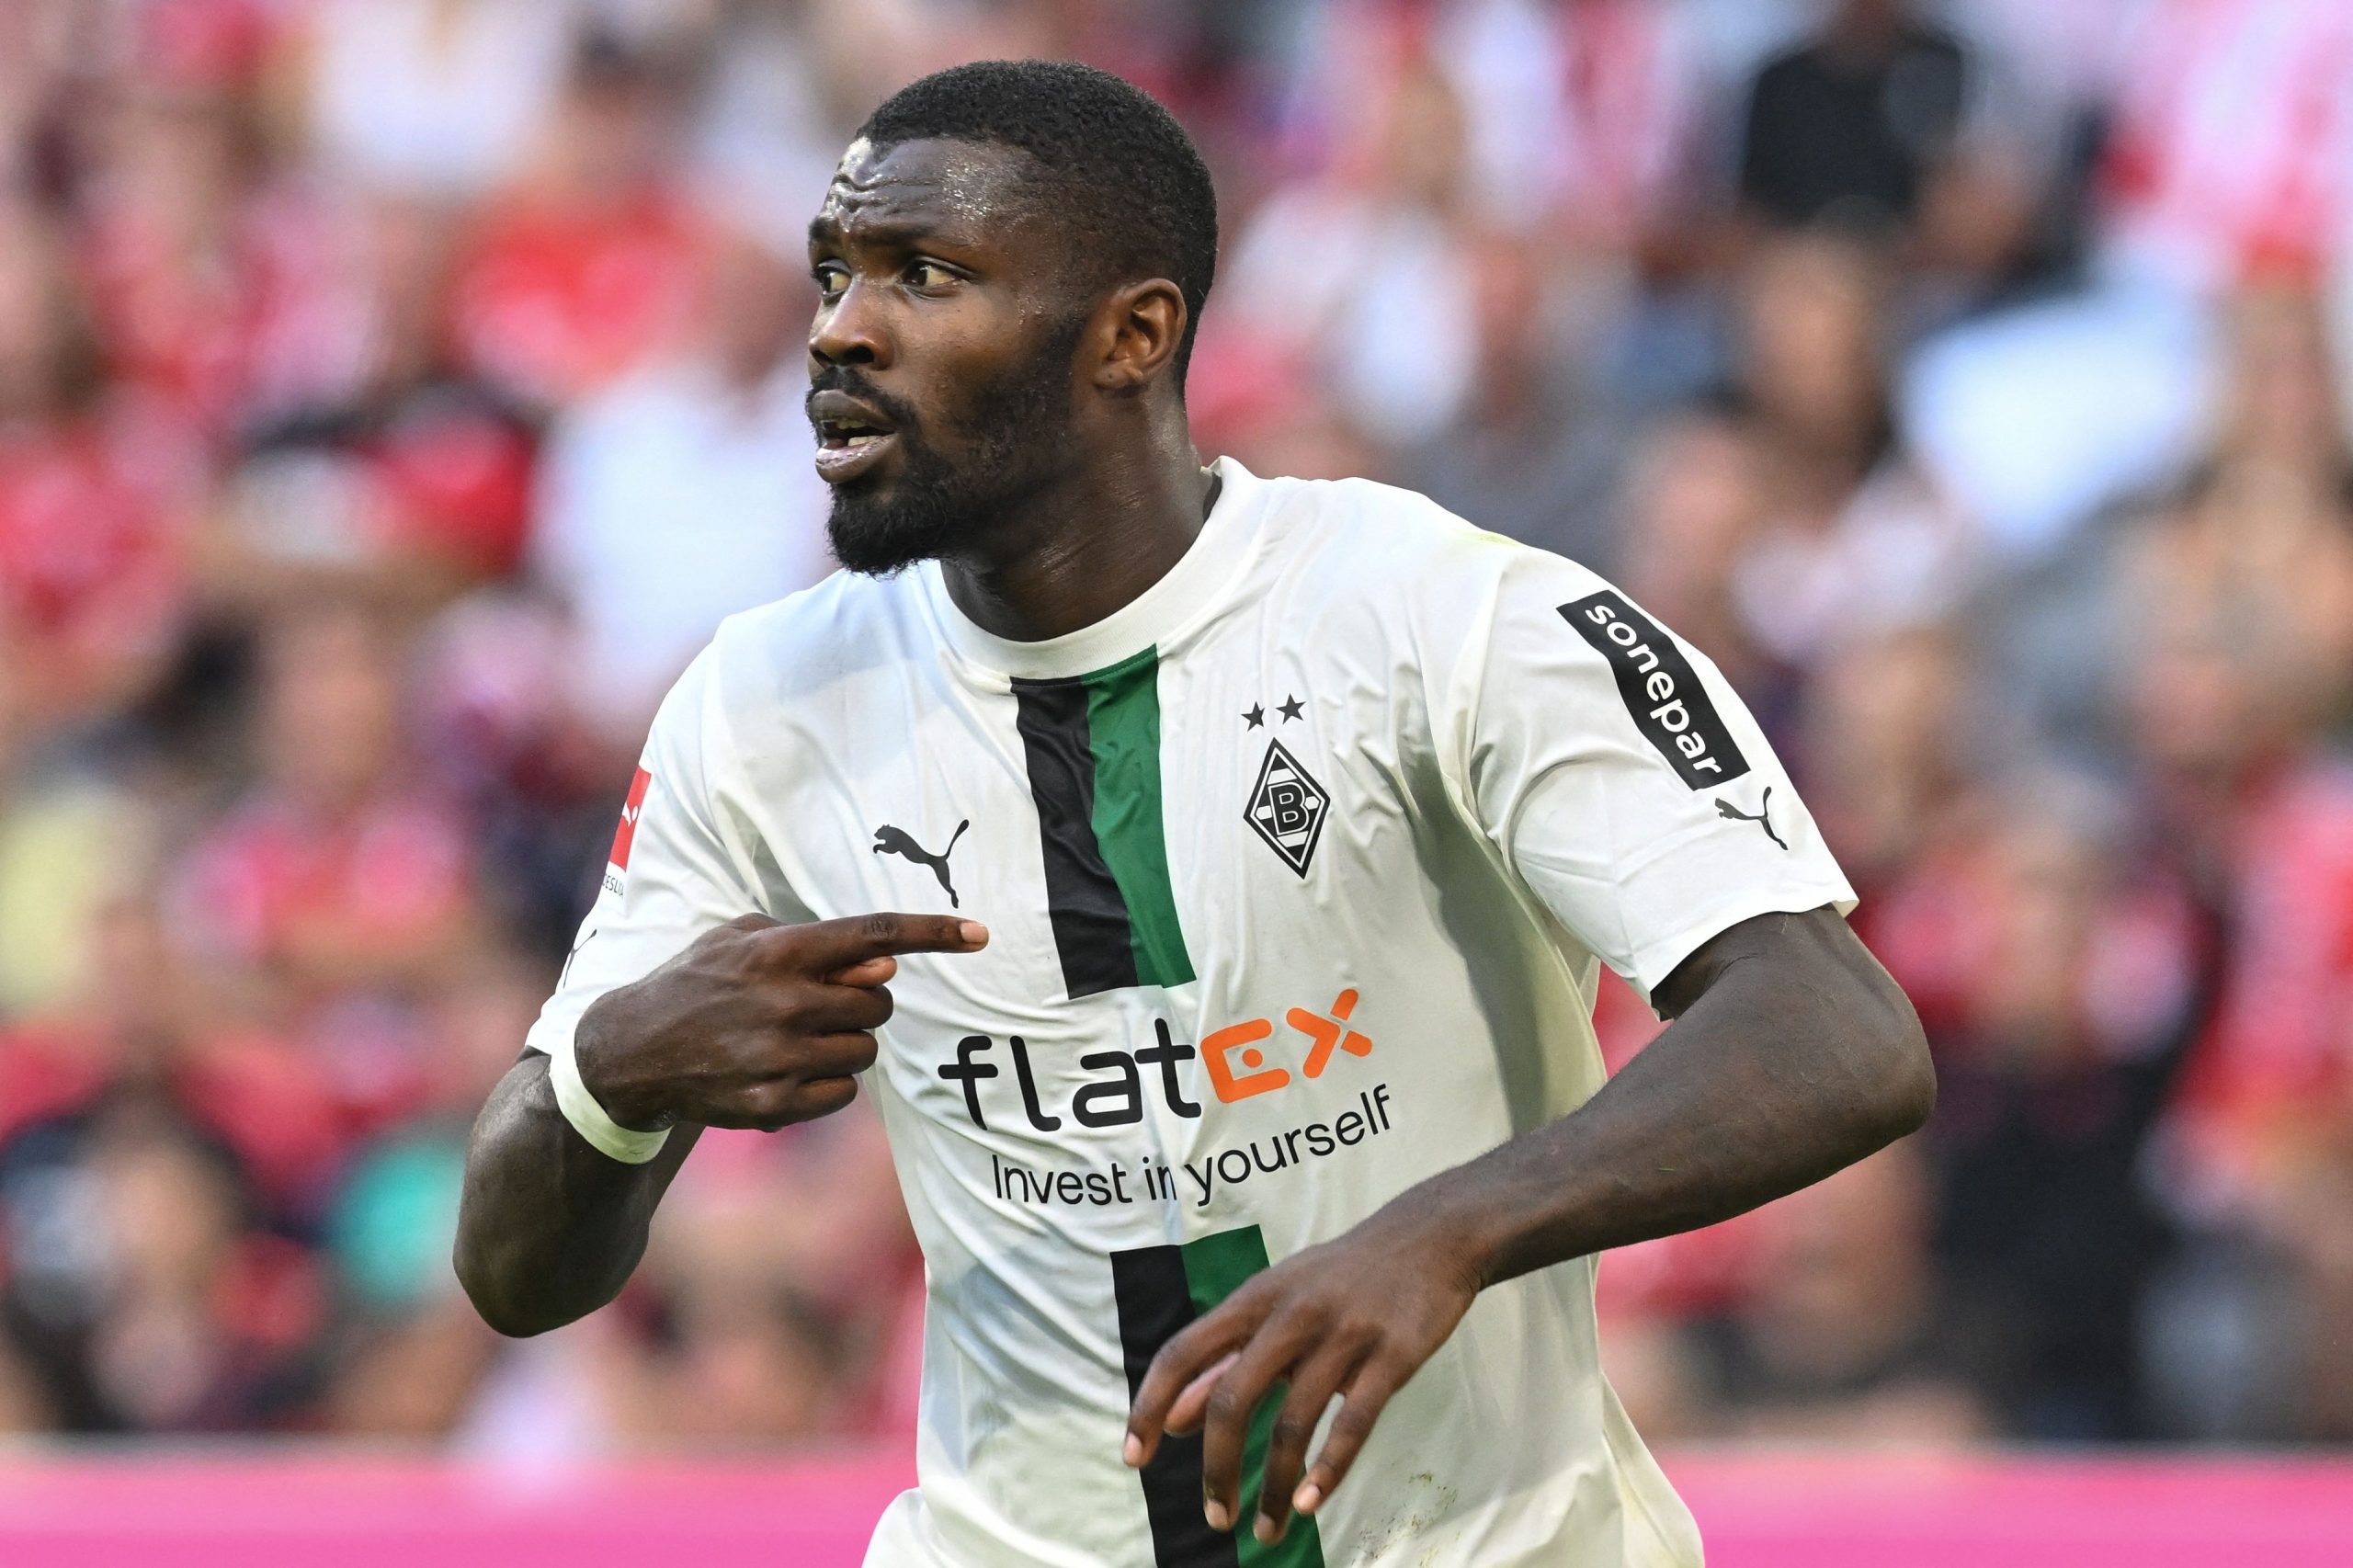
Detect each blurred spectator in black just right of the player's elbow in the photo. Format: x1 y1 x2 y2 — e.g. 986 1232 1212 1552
1929 779 2217 1441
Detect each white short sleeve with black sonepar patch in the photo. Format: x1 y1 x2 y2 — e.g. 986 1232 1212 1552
1454 546 1854 998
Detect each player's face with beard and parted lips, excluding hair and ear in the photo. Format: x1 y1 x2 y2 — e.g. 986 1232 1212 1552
810 142 1087 574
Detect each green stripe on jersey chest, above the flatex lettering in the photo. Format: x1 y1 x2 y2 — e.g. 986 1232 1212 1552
1083 647 1193 986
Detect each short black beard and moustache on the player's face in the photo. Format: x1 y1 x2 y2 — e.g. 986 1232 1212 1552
810 315 1087 577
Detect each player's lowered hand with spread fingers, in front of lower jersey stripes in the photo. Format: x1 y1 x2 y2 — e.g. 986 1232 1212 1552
1127 1208 1480 1542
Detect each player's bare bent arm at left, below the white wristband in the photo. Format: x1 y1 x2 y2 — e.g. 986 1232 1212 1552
457 1055 701 1335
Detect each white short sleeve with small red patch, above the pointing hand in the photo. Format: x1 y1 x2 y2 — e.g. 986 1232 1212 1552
525 650 772 1055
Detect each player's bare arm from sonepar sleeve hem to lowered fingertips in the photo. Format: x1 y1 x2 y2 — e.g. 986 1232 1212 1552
1127 909 1937 1540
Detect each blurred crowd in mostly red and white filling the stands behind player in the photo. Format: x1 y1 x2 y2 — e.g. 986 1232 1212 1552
0 0 2353 1458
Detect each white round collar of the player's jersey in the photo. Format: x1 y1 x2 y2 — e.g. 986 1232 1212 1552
915 445 1268 680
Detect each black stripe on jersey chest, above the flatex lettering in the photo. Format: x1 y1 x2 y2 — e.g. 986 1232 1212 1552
1014 680 1136 1001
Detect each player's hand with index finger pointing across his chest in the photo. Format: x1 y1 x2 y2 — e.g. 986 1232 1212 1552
574 914 988 1132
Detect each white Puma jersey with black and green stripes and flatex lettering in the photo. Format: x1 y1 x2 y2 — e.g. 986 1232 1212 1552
532 460 1854 1568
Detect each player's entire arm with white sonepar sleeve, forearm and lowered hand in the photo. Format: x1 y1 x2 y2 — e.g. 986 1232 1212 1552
1127 540 1934 1535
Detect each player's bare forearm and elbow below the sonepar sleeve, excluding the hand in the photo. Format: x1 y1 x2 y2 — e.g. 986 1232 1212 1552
1393 911 1934 1283
